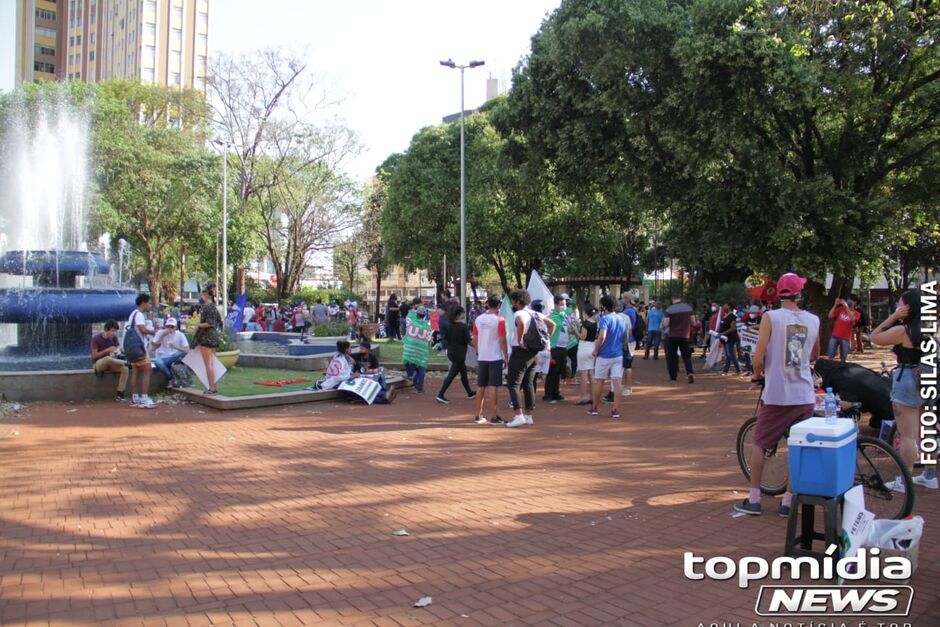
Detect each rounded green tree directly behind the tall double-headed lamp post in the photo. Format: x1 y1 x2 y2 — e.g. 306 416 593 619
381 101 586 291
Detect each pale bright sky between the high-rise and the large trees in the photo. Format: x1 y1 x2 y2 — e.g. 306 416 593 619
209 0 561 180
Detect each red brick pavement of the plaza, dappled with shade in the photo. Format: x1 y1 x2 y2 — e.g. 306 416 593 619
0 361 940 625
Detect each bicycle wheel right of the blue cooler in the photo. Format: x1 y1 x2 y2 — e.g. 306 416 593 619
855 436 914 519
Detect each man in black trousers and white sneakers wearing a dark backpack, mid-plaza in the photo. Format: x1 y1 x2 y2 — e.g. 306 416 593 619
506 289 555 428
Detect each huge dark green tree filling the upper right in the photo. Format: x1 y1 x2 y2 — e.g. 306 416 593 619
510 0 940 310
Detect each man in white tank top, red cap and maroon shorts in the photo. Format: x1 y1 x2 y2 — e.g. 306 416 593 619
734 273 819 517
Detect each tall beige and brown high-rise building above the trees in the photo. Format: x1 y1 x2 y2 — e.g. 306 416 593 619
13 0 209 89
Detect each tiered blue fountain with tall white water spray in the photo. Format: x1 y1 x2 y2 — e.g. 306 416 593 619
0 89 135 388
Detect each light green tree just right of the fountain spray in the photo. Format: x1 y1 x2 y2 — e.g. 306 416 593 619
94 82 220 310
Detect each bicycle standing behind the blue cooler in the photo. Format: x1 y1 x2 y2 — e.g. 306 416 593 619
737 382 914 519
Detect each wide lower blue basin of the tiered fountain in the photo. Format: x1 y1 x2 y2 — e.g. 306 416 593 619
0 287 137 324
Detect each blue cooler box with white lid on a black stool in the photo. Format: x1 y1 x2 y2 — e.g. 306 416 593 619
787 418 858 496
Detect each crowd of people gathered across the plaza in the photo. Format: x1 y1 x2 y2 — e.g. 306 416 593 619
91 274 937 506
